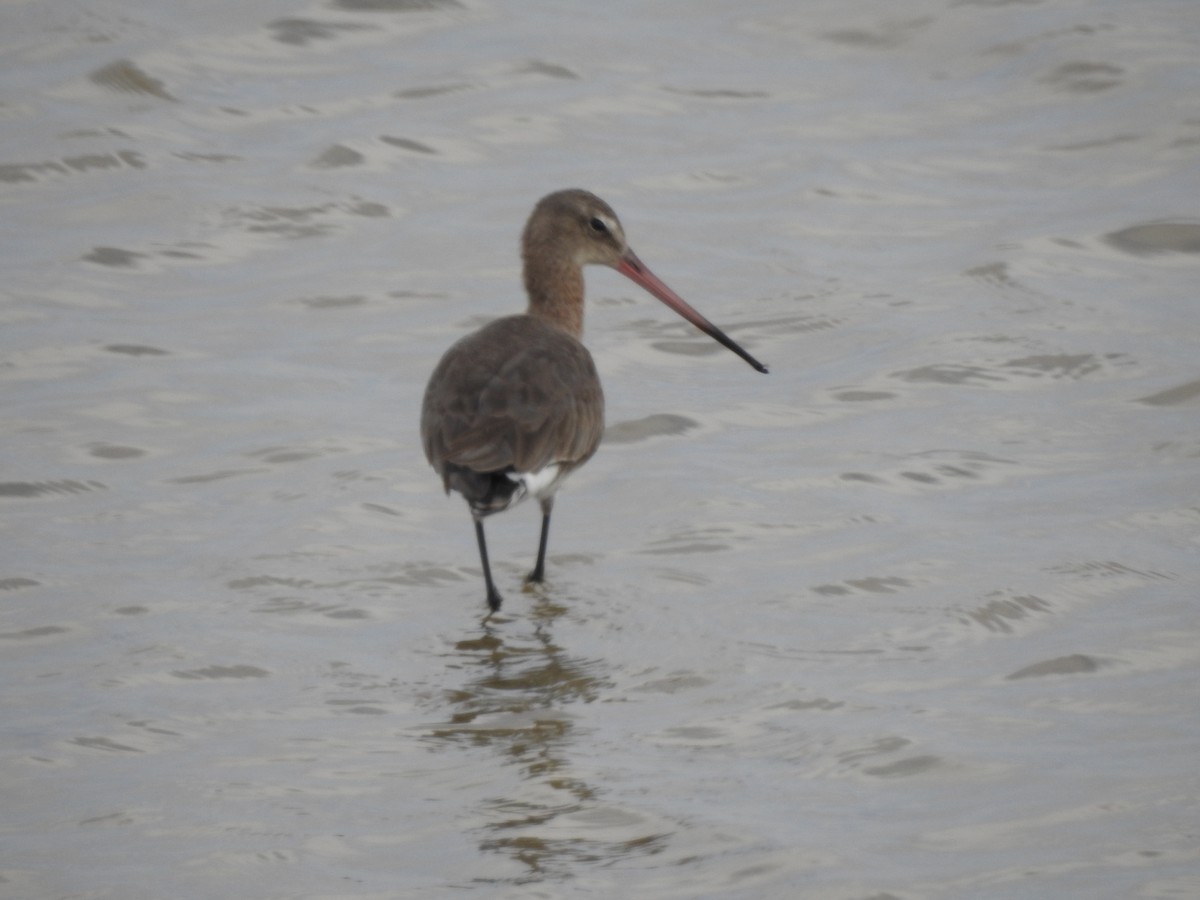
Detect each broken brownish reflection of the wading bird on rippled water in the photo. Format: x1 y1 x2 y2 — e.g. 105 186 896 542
431 598 666 881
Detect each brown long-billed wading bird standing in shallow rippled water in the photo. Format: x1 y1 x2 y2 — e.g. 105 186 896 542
421 188 767 616
